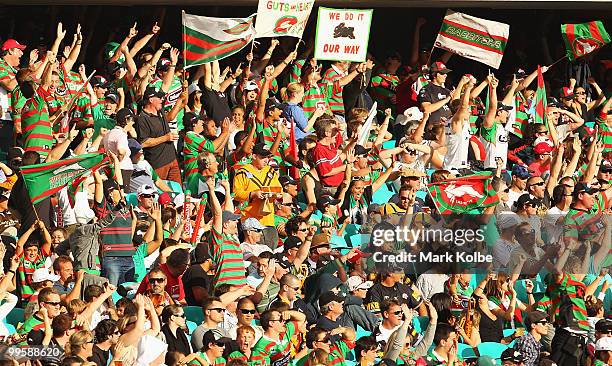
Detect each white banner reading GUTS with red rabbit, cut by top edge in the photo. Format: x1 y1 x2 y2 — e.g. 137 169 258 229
255 0 314 38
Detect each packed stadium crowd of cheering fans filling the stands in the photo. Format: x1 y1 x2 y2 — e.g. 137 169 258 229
0 10 612 366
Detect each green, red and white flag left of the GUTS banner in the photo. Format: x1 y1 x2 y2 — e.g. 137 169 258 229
183 11 255 68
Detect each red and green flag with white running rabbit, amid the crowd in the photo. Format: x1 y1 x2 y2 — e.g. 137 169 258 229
427 173 499 215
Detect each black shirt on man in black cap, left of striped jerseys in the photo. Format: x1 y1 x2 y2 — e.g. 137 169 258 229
136 111 176 169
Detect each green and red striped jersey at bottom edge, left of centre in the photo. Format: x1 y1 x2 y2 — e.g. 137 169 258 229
251 321 298 366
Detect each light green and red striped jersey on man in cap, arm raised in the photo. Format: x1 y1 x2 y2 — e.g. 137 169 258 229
210 229 246 287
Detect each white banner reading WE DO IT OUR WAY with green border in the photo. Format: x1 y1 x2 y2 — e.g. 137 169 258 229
315 7 373 62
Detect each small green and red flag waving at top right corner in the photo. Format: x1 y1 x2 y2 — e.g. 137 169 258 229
561 20 610 61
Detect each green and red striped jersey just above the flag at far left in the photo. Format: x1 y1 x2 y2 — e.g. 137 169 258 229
21 87 53 158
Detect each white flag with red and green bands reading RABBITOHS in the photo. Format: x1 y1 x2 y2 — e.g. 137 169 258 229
434 10 510 69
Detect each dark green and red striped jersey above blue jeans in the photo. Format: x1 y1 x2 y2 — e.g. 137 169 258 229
95 198 136 257
